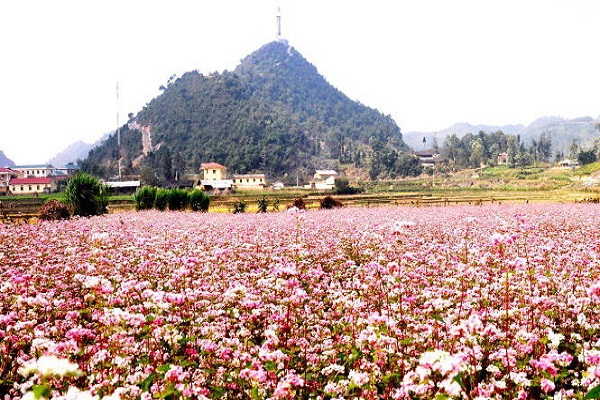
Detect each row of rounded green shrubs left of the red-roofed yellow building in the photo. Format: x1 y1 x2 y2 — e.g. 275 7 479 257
133 186 210 212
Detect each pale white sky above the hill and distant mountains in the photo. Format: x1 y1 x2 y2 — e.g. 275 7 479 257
0 0 600 164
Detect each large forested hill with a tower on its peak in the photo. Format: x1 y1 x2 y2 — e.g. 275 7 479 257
83 42 407 179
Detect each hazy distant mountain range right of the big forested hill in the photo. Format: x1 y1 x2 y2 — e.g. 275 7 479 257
402 116 600 154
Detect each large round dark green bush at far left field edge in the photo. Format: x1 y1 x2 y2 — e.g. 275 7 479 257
65 172 108 217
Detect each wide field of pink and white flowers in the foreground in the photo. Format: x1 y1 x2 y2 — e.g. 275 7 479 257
0 204 600 400
